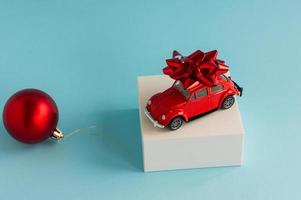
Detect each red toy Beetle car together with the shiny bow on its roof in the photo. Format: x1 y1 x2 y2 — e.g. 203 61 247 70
145 50 242 130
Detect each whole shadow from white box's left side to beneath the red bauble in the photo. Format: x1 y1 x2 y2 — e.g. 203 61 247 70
0 109 143 171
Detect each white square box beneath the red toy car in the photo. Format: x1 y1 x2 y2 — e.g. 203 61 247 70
138 75 244 172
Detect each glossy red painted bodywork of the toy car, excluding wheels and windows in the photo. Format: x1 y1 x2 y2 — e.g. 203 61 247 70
146 75 239 126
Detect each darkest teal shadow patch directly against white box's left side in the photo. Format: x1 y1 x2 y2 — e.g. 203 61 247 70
100 109 143 171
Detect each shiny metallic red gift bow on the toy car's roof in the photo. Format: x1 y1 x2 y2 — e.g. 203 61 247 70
163 50 229 87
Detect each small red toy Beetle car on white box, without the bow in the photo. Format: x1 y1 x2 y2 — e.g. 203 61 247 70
145 49 242 130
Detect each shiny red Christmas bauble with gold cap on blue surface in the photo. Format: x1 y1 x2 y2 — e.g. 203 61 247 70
3 89 64 144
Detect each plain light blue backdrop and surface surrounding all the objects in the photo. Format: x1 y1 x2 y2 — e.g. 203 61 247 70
0 0 301 200
